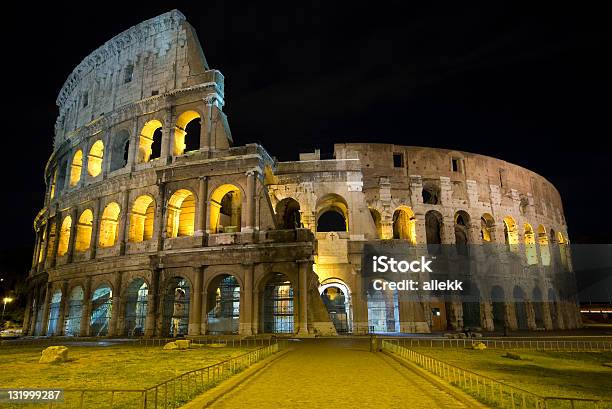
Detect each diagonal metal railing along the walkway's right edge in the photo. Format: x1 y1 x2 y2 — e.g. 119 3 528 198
382 340 612 409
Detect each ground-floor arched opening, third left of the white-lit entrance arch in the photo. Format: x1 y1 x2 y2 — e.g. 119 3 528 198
162 277 191 337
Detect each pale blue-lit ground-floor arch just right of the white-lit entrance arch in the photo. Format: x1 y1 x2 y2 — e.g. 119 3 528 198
367 280 400 334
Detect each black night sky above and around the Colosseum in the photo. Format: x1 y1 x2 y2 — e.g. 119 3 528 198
0 1 612 286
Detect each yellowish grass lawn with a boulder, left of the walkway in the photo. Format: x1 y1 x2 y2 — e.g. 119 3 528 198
0 344 254 408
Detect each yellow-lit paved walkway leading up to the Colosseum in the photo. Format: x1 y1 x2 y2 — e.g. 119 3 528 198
212 339 465 409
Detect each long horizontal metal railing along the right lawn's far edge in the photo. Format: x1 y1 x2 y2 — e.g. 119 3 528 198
382 338 612 352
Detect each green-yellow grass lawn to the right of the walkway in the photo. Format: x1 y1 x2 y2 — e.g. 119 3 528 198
412 348 612 399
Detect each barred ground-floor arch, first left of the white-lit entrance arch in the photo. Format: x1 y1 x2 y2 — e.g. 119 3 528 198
263 273 294 334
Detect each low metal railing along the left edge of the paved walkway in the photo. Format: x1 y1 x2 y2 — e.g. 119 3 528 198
15 340 279 409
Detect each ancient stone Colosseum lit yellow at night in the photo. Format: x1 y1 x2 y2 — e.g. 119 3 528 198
24 10 581 337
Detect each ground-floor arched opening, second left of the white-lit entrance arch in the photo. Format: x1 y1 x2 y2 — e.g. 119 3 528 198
206 274 240 334
